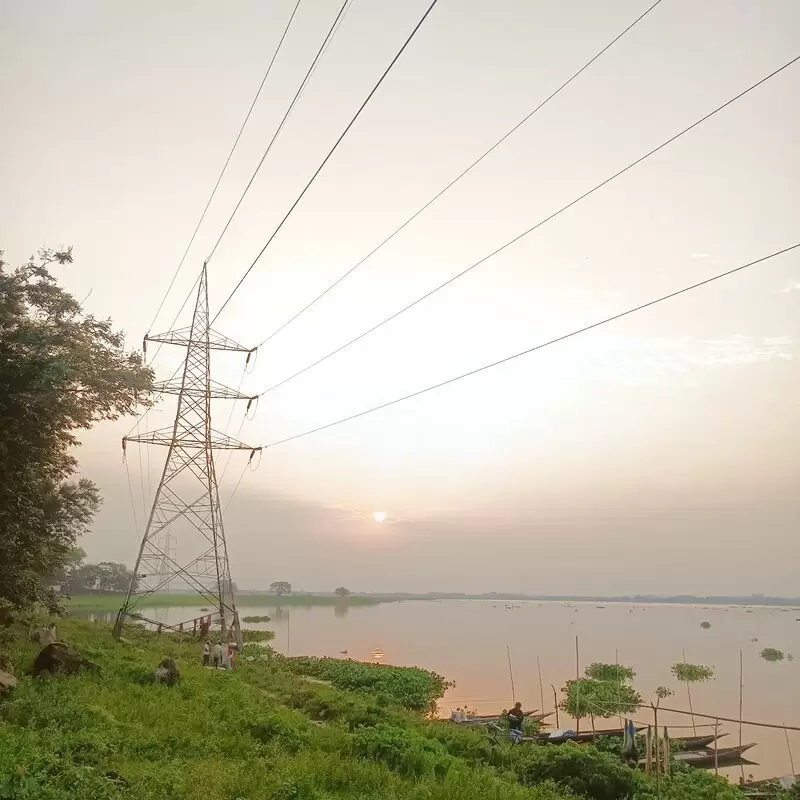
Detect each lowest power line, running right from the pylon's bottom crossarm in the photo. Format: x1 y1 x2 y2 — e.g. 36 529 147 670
263 242 800 449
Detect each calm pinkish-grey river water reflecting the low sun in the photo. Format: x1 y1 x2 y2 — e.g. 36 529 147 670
115 600 800 780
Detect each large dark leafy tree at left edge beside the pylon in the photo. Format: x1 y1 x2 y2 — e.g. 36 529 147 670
0 249 153 609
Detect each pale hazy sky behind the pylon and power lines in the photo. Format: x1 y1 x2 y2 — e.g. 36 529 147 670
0 0 800 594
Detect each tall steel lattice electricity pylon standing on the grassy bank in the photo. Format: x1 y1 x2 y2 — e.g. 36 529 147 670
114 264 260 644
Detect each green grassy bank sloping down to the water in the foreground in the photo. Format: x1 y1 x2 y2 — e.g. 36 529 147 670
0 620 752 800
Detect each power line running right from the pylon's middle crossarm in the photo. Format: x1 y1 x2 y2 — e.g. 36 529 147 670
261 51 800 395
